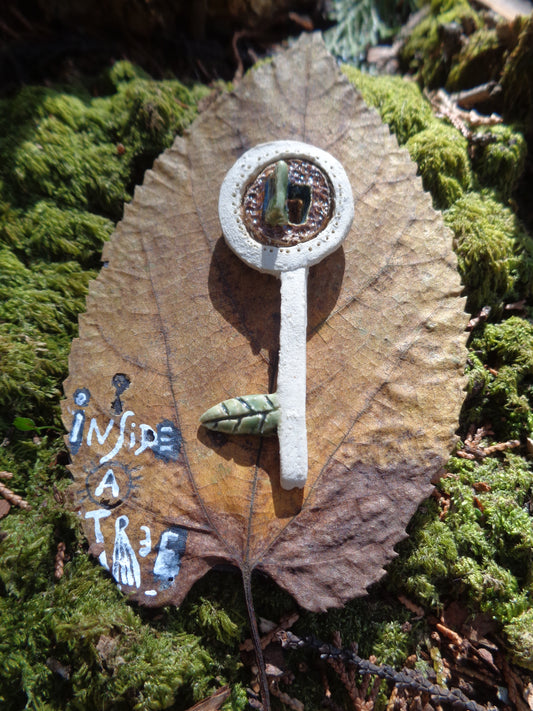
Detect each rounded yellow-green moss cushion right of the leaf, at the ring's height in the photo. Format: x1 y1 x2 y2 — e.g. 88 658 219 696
444 193 533 313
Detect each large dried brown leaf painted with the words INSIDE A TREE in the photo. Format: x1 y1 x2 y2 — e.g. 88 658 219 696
63 36 466 610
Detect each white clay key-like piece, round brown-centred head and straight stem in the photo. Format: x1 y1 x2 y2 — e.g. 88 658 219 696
219 141 354 489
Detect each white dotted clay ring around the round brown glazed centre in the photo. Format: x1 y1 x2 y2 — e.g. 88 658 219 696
218 141 354 275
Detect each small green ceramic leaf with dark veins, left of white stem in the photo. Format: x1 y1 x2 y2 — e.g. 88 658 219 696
200 393 279 435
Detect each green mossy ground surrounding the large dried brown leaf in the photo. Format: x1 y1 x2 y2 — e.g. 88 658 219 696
0 8 533 711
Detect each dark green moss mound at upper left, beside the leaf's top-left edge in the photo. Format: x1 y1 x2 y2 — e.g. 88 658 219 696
0 62 208 219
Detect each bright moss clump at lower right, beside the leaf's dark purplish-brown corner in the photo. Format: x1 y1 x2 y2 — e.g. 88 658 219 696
392 454 533 624
